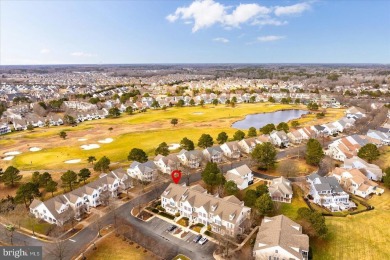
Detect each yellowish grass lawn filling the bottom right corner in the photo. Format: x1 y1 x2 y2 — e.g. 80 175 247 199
310 186 390 260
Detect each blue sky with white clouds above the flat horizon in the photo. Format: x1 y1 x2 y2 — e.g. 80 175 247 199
0 0 390 65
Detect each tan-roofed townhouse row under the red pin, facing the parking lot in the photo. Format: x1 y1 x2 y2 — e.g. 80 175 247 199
161 183 251 237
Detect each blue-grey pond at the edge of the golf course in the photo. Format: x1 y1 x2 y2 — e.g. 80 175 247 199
232 109 308 129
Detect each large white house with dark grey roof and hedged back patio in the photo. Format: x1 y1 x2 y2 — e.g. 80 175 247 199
307 173 356 212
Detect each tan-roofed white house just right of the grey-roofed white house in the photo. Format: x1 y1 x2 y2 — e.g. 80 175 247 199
329 167 378 198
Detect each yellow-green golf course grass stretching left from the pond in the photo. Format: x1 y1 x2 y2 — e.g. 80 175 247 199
0 103 340 173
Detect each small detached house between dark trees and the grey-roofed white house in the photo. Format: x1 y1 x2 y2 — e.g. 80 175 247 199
268 176 293 203
